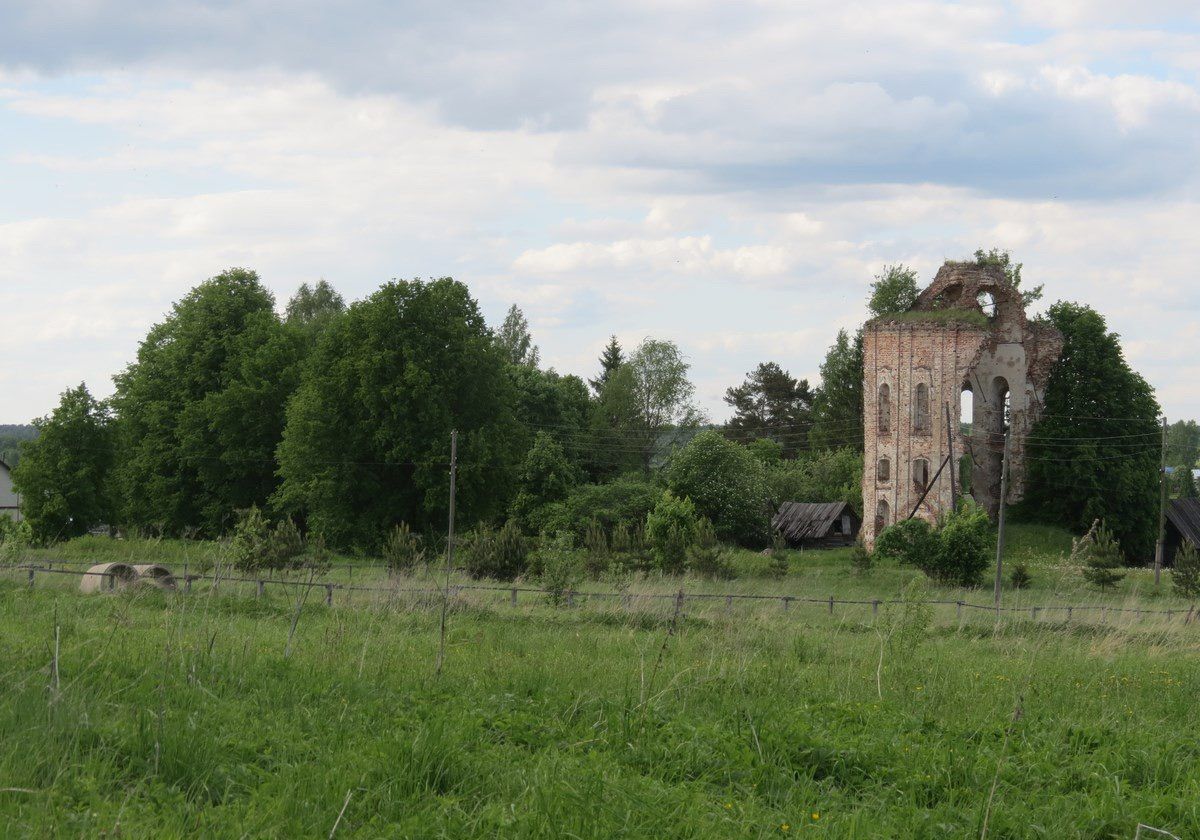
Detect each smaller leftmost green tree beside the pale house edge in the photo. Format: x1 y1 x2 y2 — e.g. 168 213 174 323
12 384 113 542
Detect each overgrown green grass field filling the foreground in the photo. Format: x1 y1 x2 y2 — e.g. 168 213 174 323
0 529 1200 838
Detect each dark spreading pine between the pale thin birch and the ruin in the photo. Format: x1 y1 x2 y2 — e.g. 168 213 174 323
725 361 812 457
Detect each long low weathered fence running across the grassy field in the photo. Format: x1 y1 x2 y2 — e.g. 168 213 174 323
0 563 1196 624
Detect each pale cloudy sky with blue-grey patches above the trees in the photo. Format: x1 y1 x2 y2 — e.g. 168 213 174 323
0 0 1200 422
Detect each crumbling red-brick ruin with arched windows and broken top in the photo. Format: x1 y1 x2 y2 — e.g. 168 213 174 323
863 262 1062 546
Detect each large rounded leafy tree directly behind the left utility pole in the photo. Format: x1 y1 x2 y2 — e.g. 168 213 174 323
276 277 522 547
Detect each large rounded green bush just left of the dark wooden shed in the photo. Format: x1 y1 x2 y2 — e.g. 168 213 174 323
667 431 768 546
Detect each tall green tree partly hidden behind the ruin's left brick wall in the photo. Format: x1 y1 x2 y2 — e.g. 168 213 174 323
809 330 863 452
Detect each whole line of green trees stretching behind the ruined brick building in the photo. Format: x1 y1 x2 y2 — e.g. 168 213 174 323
7 250 1171 564
